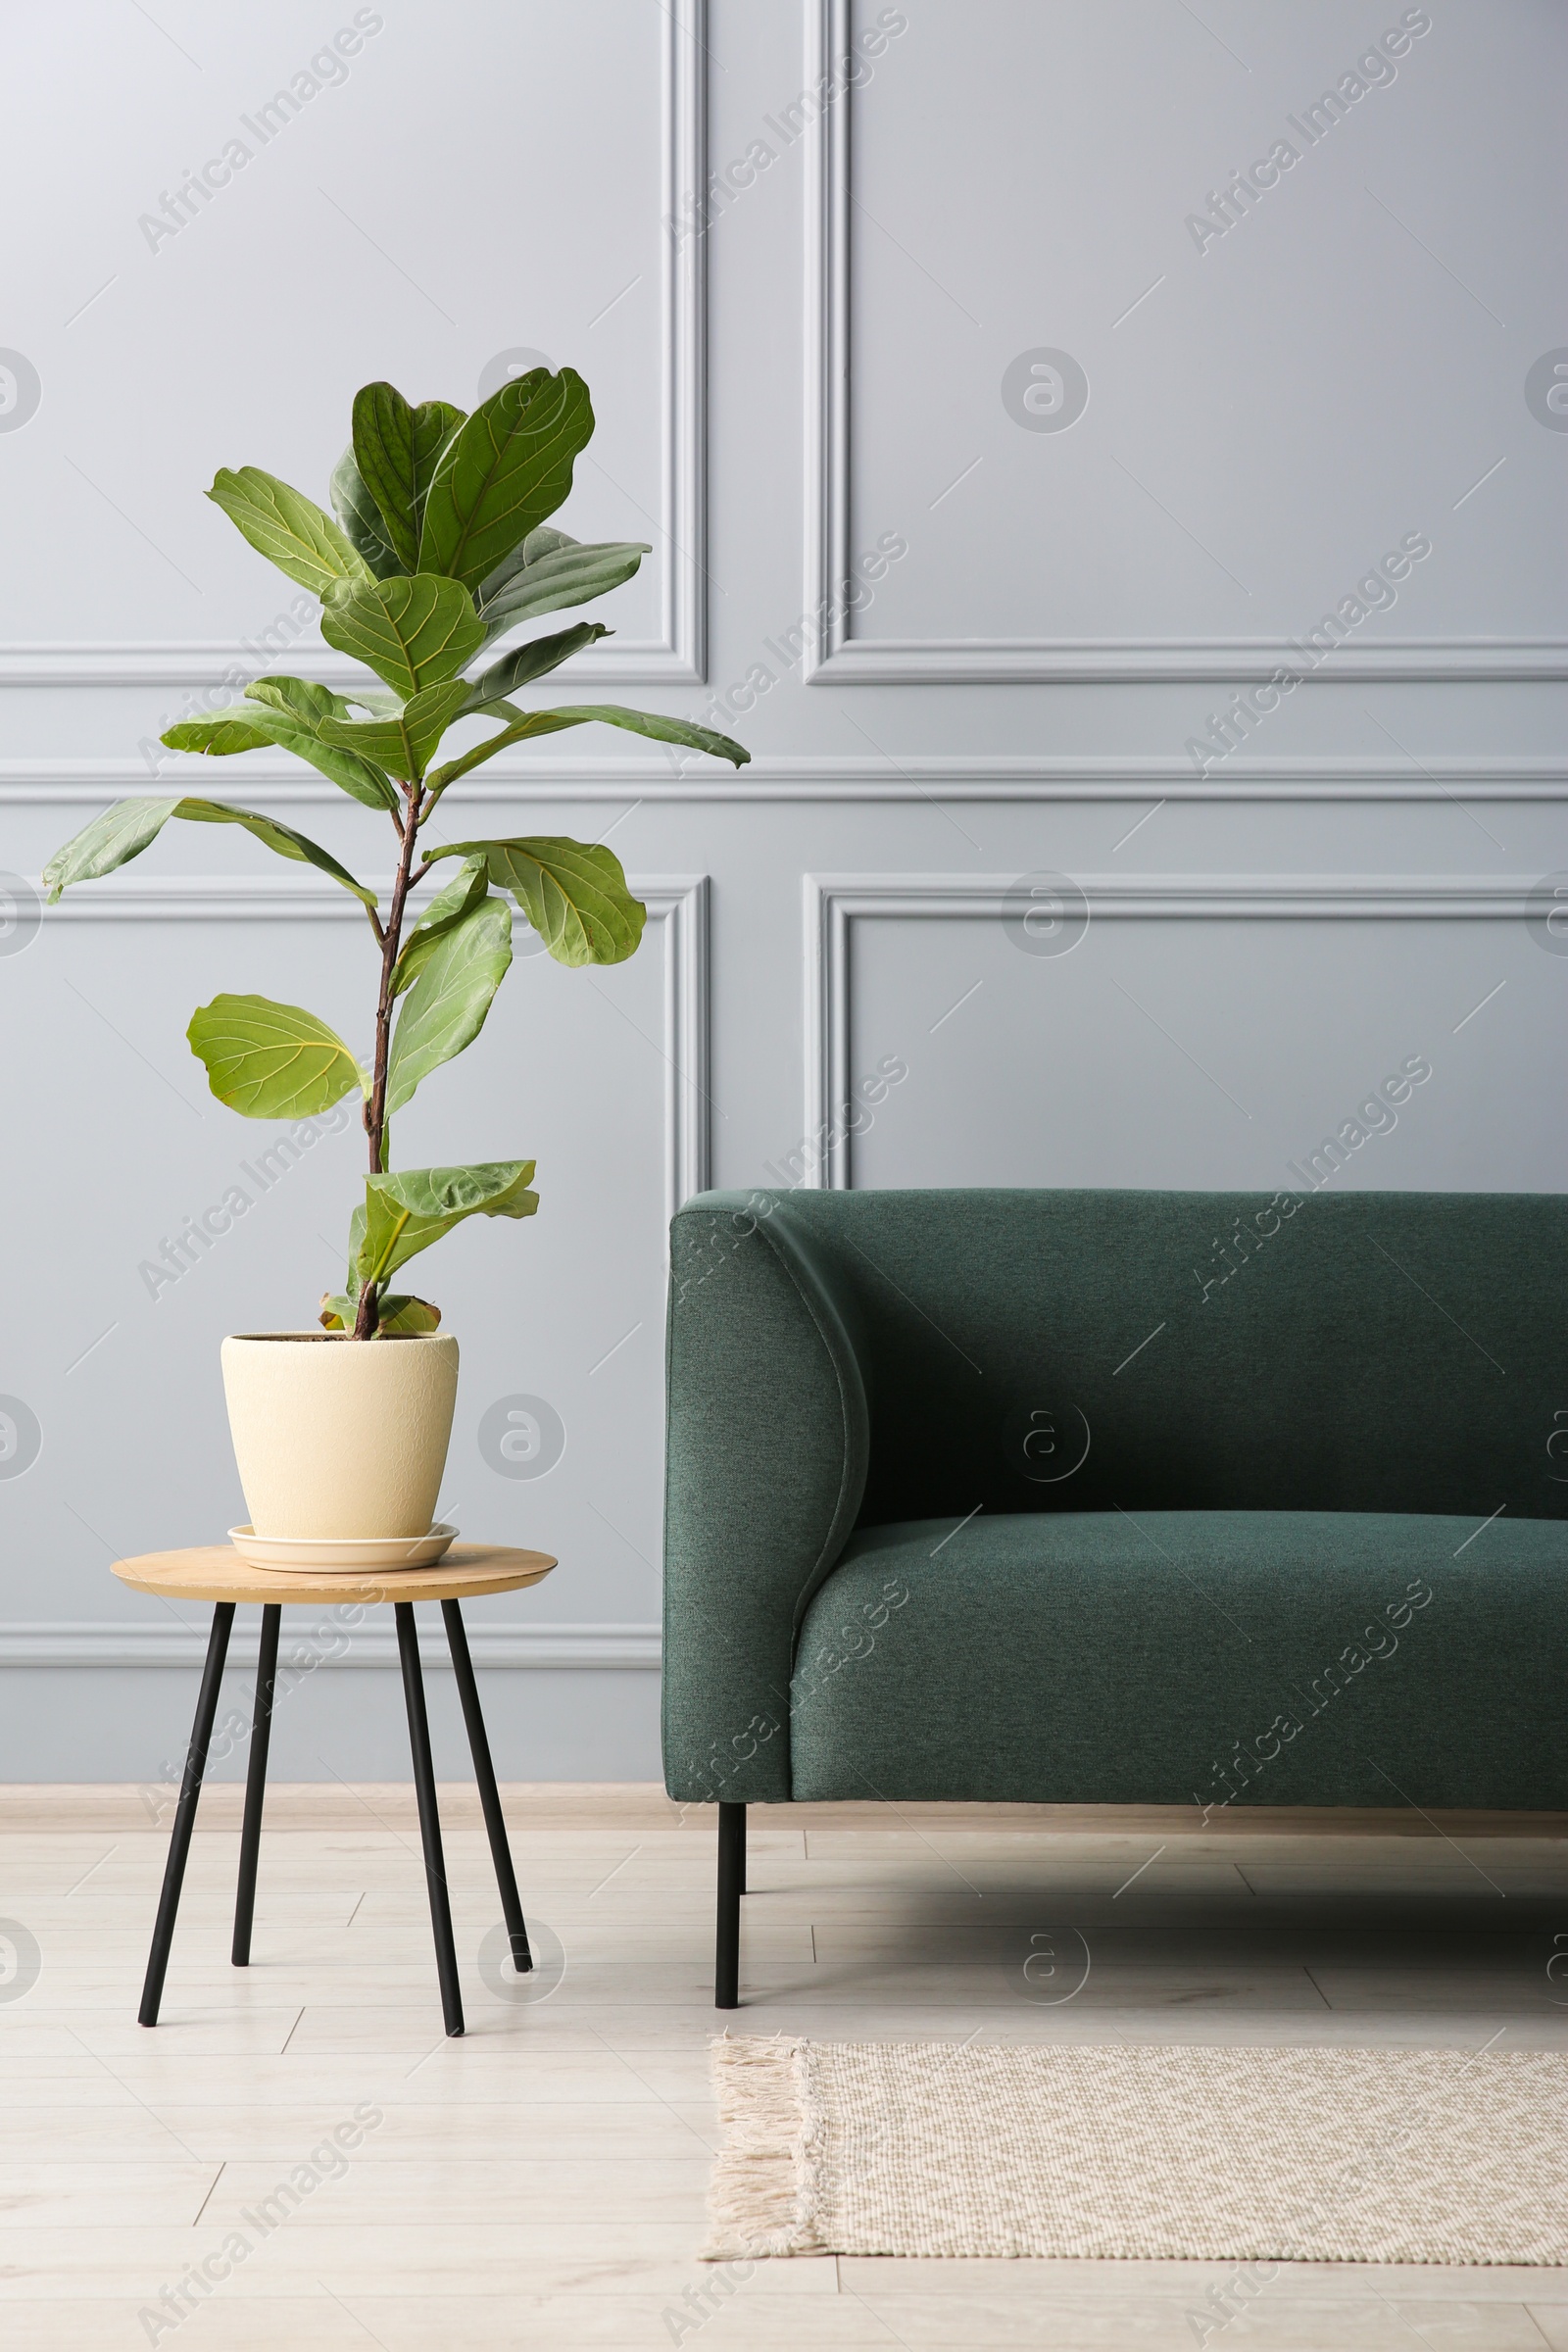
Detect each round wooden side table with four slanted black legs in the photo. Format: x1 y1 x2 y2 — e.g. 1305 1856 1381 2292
116 1543 555 2034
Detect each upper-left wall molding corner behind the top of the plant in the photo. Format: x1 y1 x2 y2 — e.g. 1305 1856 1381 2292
0 0 708 692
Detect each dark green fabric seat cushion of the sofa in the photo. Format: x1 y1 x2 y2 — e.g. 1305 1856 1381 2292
790 1510 1568 1811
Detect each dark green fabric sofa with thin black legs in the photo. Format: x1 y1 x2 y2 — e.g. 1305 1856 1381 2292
662 1190 1568 2006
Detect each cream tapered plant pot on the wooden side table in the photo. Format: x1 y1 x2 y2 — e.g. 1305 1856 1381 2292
223 1331 459 1541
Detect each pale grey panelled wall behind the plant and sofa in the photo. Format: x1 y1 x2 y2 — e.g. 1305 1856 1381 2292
0 0 1568 1778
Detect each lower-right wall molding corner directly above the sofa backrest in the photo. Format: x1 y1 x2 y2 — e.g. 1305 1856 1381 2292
802 872 1540 1193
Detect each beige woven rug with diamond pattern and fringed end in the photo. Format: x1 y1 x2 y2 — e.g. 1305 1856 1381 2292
706 2036 1568 2263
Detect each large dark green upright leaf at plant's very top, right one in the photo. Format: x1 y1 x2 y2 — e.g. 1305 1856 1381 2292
418 367 592 588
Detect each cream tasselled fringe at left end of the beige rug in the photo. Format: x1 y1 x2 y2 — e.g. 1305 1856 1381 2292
701 2034 827 2263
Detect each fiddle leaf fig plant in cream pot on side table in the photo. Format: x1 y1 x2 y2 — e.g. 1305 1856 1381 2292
45 367 750 1543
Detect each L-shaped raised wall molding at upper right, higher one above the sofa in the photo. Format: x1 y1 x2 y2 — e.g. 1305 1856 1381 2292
802 0 1568 687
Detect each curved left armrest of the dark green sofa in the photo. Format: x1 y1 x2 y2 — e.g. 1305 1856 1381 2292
662 1193 870 1804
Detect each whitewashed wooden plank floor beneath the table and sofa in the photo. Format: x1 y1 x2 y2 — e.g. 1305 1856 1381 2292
0 1788 1568 2352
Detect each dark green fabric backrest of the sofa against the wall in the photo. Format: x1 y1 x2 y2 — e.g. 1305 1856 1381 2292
714 1190 1568 1524
